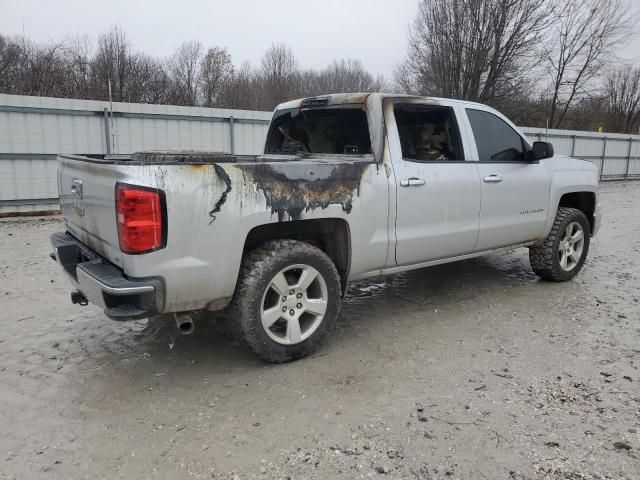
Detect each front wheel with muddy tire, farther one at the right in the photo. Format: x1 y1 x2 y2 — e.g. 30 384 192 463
529 207 591 282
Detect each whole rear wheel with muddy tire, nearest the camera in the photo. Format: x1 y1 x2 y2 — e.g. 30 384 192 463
227 240 341 363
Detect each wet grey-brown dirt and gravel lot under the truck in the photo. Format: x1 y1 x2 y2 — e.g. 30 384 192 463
0 182 640 480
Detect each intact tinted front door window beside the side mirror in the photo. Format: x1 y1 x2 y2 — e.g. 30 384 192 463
467 108 526 162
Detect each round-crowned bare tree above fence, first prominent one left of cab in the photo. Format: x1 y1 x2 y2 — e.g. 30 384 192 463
198 47 233 107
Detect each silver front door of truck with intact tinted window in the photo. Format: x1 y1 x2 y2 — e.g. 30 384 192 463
466 107 550 250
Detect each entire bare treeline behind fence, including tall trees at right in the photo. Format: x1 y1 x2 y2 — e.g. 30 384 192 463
0 0 640 133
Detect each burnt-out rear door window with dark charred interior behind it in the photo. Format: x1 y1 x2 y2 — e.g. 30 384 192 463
394 104 464 162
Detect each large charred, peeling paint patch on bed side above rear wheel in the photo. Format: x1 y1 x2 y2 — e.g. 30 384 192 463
236 162 372 222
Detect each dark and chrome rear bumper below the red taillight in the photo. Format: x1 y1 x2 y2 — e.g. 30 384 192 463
51 232 163 320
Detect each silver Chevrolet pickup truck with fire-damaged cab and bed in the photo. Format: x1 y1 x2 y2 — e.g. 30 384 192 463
51 94 601 362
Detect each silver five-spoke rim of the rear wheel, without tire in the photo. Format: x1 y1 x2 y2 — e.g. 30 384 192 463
260 264 329 345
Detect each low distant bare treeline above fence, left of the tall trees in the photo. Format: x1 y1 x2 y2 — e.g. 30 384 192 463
0 26 385 110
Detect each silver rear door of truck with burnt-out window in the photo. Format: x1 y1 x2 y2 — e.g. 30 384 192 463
385 99 480 265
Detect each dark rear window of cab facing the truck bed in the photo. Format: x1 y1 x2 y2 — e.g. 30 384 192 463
265 106 371 155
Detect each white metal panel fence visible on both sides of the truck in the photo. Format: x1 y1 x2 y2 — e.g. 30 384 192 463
0 95 640 215
